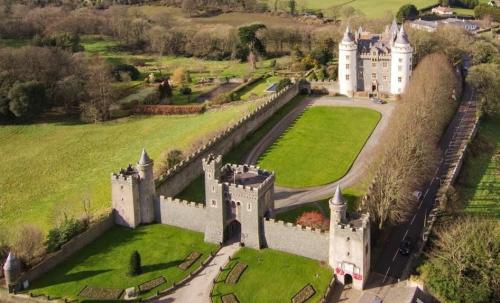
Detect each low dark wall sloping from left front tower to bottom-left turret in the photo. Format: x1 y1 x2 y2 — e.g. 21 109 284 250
19 214 114 282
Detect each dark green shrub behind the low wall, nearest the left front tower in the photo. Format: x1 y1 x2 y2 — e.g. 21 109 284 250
45 216 88 252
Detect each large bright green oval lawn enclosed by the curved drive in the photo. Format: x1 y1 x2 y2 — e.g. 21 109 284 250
258 106 380 188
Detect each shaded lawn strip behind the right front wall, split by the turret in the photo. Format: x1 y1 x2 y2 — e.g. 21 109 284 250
276 187 364 224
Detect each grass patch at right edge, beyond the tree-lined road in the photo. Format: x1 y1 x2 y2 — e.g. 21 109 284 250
459 115 500 218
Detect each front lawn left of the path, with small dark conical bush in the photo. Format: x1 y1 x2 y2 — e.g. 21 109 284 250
30 224 217 300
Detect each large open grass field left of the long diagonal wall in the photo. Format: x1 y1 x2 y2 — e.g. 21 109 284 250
0 103 255 238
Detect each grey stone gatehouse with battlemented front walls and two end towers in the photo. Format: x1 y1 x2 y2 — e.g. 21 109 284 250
111 150 371 289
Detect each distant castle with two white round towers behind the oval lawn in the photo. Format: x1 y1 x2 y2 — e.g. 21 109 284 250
338 20 413 96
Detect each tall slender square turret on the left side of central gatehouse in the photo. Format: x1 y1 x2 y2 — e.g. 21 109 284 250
203 155 227 243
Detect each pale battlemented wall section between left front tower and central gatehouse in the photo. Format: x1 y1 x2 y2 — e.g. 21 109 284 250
160 196 206 232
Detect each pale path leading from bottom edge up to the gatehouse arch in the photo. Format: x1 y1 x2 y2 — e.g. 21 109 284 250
152 242 240 303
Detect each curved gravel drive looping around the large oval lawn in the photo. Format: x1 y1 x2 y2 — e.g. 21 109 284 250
245 97 394 211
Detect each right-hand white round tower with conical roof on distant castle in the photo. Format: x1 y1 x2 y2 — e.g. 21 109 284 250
391 25 413 95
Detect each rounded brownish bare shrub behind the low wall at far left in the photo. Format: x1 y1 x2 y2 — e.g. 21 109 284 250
13 225 44 267
